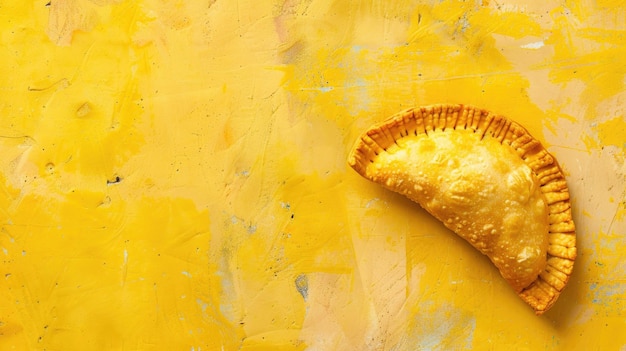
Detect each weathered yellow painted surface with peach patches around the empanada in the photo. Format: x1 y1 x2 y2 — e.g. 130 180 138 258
0 0 626 351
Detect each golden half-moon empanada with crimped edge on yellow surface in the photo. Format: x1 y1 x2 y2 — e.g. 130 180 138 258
348 105 576 314
